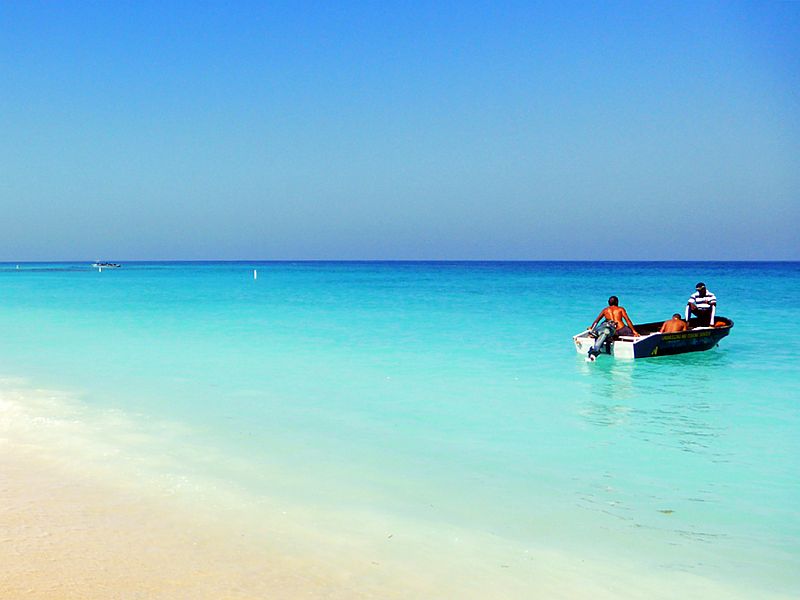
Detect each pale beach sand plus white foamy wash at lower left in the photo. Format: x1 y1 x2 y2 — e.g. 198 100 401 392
0 380 406 599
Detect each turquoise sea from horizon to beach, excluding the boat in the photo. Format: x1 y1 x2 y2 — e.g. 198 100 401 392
0 262 800 598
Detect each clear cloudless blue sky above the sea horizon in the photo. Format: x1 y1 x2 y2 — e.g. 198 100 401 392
0 0 800 261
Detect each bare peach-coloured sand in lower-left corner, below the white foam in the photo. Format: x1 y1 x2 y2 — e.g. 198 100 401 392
0 444 396 598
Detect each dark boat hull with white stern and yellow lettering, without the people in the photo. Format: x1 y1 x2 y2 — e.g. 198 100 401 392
572 317 733 358
